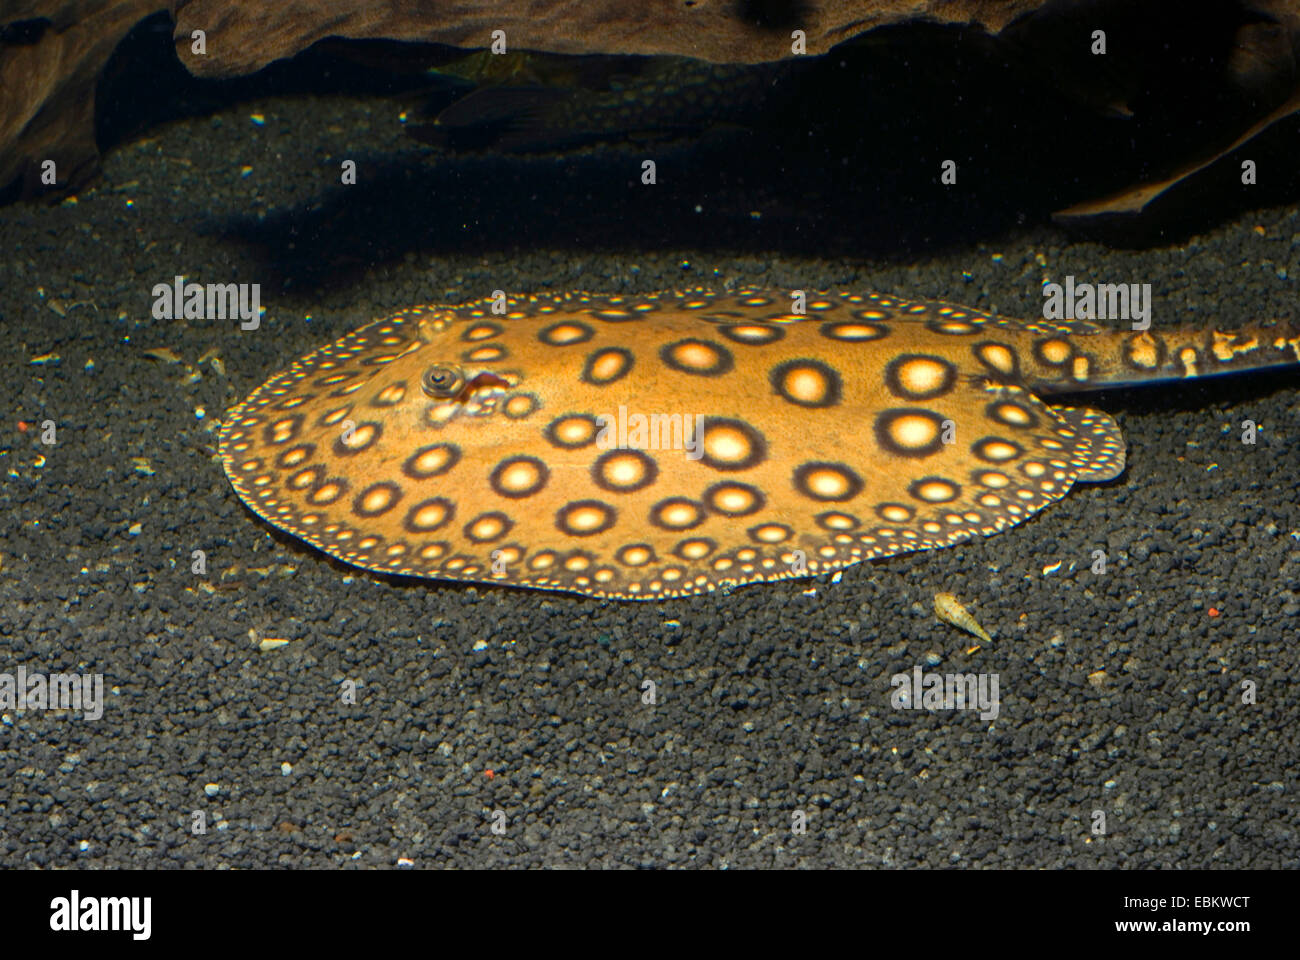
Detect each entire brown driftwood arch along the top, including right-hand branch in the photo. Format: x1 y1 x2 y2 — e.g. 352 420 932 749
0 0 1300 222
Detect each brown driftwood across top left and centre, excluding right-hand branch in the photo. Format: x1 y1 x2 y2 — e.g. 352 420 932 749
0 0 1044 195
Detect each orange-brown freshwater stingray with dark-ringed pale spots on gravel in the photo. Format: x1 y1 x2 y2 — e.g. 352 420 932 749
218 287 1300 600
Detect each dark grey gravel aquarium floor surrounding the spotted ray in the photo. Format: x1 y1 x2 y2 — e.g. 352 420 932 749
0 98 1300 868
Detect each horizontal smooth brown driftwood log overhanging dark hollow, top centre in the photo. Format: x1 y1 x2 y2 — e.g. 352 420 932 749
176 0 1045 77
